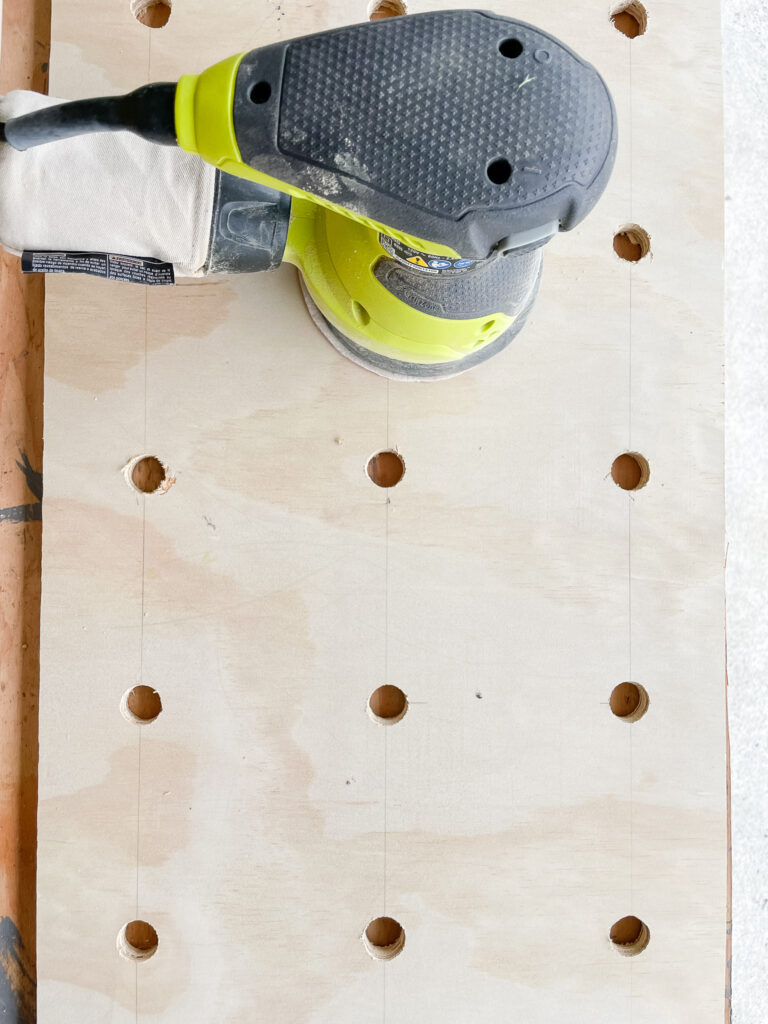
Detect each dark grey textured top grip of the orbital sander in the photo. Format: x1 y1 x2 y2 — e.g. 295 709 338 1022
234 10 616 258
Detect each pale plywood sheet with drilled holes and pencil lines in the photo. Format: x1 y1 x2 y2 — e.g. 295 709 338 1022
38 0 726 1024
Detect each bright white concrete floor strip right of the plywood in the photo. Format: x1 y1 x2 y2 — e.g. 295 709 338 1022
722 0 768 1024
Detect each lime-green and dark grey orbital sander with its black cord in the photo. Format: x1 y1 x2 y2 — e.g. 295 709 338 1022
0 10 616 380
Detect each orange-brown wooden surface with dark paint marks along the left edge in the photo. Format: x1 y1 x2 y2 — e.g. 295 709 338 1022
0 0 50 1024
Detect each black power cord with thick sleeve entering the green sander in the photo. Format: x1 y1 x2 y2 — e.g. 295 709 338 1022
0 82 176 150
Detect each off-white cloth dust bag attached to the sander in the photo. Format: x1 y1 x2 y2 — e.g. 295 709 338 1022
0 90 216 276
